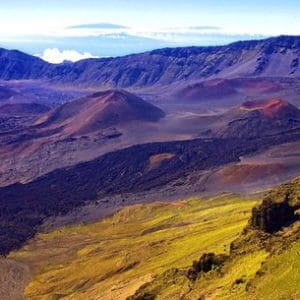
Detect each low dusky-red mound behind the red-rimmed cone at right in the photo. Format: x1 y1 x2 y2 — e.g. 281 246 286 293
170 77 288 110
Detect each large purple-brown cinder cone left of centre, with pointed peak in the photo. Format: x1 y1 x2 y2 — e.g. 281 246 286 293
35 90 165 134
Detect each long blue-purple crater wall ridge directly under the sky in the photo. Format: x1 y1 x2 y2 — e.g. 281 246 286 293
0 36 300 88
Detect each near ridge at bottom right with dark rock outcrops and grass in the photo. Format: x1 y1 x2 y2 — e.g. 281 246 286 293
127 178 300 300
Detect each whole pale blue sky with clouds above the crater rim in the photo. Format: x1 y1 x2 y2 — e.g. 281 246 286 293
0 0 300 63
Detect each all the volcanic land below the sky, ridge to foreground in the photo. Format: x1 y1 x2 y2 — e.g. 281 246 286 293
0 36 300 300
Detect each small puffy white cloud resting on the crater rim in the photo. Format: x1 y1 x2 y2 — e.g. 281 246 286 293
36 48 98 64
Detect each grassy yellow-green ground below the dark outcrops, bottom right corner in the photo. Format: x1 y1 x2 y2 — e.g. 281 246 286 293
130 222 300 300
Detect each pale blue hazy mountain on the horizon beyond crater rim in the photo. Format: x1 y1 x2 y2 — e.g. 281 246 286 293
0 32 267 58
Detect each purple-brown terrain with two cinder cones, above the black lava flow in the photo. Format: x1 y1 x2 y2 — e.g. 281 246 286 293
0 90 299 186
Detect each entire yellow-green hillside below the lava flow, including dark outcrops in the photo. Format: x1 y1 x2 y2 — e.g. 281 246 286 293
4 178 300 300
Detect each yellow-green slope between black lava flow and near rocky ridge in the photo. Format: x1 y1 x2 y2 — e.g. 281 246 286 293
10 195 255 300
